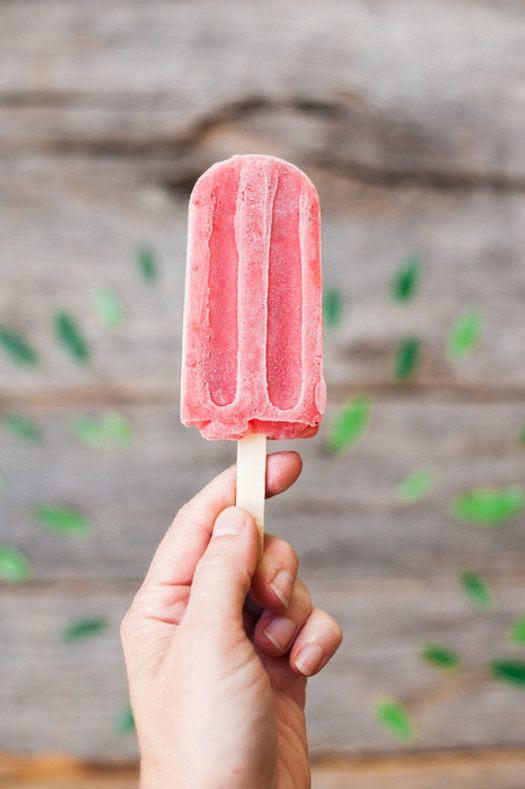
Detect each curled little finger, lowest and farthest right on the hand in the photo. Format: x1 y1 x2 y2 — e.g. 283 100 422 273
290 608 343 677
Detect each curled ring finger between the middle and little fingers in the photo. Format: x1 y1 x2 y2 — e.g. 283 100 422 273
255 578 312 657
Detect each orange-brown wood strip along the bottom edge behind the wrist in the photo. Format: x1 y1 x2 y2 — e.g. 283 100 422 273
0 748 525 789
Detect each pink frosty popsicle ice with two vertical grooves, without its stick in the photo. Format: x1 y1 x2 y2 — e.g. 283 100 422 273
181 155 326 439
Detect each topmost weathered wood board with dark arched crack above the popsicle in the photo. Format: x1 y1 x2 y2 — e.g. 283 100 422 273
0 0 525 189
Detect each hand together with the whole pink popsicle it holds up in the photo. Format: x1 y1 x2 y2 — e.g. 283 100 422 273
122 155 341 789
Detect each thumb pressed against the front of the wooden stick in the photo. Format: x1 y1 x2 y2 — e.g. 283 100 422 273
184 507 257 628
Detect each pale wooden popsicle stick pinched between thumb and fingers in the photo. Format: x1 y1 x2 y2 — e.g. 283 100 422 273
235 433 266 559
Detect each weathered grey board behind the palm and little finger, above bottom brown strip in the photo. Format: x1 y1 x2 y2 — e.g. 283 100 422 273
0 574 525 761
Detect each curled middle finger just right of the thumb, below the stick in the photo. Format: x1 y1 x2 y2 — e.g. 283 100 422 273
250 534 299 612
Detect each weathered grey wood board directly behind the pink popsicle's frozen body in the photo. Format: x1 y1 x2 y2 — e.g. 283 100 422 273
0 159 525 402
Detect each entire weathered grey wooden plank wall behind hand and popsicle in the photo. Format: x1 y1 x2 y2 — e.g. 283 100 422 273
0 0 525 789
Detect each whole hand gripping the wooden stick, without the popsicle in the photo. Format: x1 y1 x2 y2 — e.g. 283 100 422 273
121 452 342 789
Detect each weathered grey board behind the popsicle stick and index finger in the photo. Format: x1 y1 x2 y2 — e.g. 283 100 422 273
0 397 525 584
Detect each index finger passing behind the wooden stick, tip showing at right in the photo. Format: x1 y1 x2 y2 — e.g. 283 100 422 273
144 452 302 585
